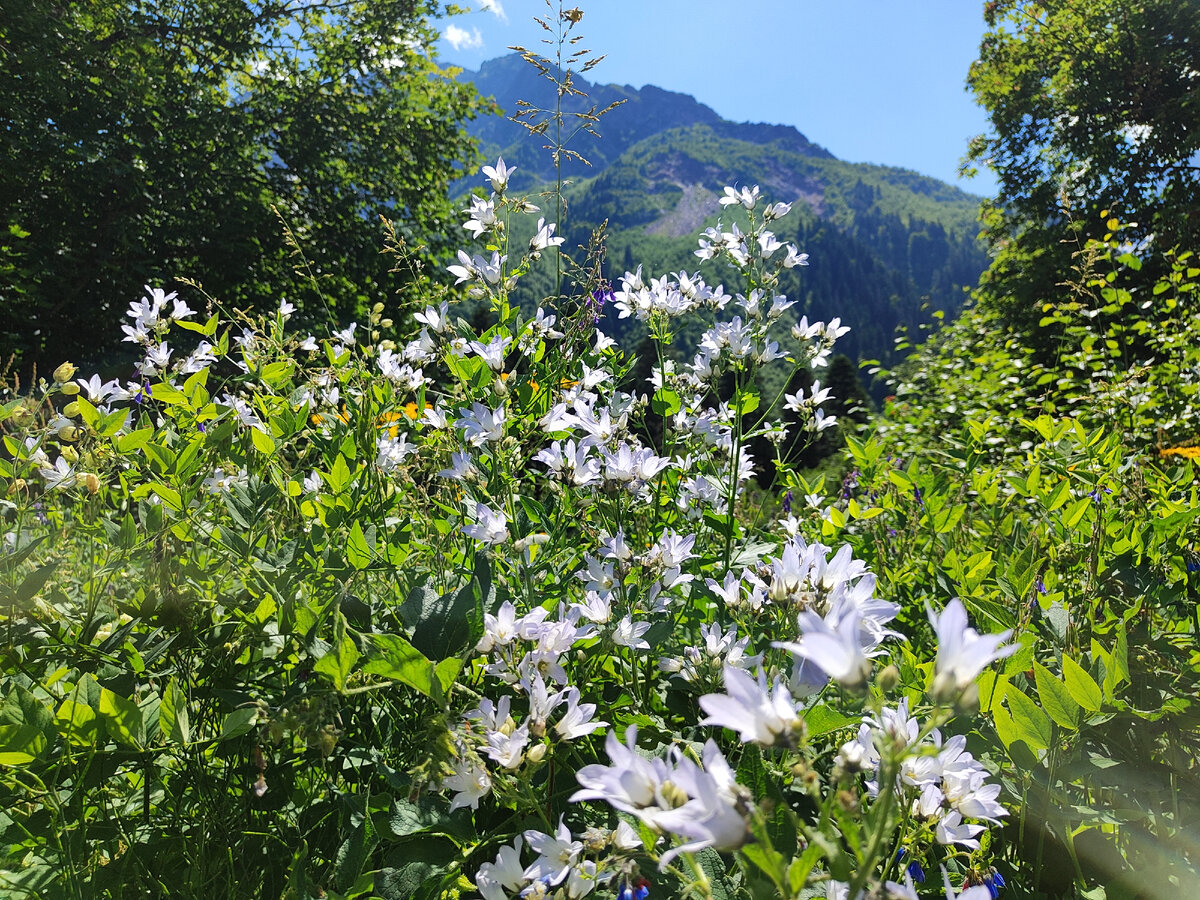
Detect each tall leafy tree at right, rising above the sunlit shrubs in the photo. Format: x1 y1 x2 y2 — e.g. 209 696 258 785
967 0 1200 330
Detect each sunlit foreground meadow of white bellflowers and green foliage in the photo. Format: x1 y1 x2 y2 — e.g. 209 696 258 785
0 6 1200 900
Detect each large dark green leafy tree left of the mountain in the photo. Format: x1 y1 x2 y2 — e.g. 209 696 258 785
0 0 480 366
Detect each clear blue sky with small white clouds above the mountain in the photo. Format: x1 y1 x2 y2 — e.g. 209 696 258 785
440 0 995 194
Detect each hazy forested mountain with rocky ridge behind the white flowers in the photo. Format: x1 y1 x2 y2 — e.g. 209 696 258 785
460 54 988 372
